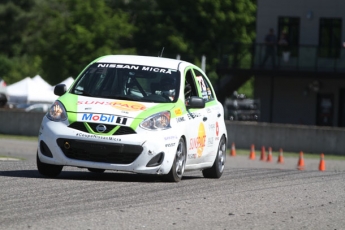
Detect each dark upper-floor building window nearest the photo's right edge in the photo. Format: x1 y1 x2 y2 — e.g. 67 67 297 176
319 18 342 58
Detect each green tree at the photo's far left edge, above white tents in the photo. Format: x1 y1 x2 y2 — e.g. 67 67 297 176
0 0 38 83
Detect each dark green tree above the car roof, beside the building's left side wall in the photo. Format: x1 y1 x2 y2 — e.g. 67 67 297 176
113 0 256 82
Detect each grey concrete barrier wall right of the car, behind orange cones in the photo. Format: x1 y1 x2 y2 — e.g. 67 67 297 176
226 121 345 156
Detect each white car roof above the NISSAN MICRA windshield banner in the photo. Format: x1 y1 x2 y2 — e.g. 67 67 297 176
94 55 192 69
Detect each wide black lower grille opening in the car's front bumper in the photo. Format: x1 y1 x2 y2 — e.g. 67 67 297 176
57 138 143 164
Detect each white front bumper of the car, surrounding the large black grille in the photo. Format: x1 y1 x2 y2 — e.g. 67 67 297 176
38 117 178 174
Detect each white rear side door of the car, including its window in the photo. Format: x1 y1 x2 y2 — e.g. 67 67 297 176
189 68 220 163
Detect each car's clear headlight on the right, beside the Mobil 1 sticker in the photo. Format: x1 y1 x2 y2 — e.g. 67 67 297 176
140 111 171 130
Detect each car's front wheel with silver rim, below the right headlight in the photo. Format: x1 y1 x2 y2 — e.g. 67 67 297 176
166 138 187 182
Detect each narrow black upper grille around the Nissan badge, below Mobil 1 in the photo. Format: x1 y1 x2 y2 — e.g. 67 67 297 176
68 122 136 136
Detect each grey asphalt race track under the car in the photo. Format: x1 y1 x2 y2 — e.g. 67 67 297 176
0 139 345 230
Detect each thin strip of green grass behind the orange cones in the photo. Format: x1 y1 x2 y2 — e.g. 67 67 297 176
227 149 345 160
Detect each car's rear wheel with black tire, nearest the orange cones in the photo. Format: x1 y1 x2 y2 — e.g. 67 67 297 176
202 136 226 178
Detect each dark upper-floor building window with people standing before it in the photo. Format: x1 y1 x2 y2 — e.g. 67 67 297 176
278 17 300 57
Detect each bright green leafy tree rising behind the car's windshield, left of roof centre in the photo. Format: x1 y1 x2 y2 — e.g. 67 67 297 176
30 0 135 84
